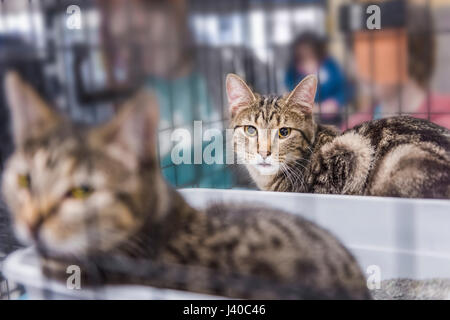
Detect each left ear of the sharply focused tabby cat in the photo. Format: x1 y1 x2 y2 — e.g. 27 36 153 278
226 73 256 117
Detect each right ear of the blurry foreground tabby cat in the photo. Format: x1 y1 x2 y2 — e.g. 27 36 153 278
91 89 159 163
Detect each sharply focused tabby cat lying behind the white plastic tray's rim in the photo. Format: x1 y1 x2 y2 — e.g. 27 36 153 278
226 74 450 199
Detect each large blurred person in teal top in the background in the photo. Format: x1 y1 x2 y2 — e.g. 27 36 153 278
100 0 231 188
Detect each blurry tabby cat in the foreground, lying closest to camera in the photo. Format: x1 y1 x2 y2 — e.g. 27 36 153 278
2 73 370 299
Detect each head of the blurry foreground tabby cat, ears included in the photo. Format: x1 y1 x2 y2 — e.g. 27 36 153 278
2 74 157 255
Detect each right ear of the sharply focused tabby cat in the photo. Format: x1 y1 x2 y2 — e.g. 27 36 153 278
286 75 317 114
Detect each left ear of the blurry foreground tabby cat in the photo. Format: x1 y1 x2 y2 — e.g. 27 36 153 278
5 71 60 146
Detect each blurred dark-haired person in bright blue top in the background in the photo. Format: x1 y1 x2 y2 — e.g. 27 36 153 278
285 32 351 124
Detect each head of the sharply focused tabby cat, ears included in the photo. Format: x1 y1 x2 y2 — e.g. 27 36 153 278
227 75 317 177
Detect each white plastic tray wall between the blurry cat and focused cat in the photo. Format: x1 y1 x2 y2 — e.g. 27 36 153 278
183 189 450 279
